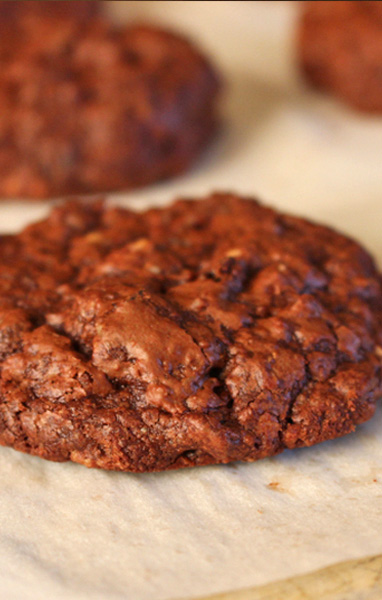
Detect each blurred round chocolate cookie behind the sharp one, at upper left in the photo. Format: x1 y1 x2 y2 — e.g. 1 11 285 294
0 1 219 198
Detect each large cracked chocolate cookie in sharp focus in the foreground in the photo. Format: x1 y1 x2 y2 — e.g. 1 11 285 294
0 194 382 471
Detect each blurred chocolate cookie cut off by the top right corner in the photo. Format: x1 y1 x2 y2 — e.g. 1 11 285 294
299 1 382 112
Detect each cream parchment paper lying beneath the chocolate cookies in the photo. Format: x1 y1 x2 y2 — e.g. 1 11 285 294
0 1 382 600
